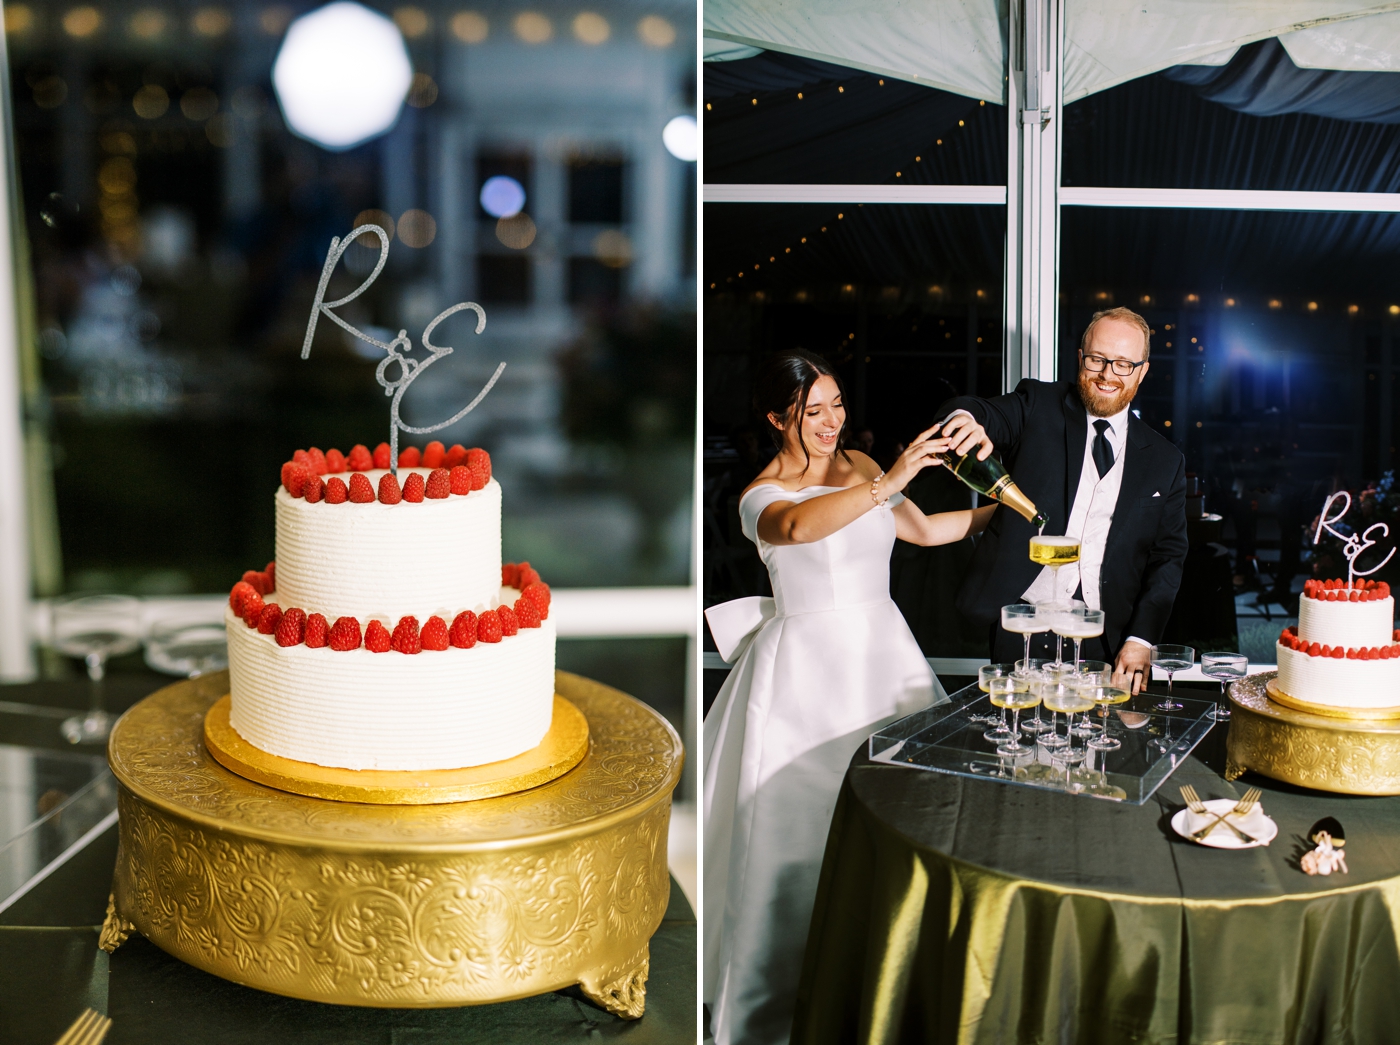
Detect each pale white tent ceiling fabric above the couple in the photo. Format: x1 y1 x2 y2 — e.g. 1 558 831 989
704 0 1400 102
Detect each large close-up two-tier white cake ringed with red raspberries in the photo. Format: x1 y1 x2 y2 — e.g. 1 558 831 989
225 443 554 770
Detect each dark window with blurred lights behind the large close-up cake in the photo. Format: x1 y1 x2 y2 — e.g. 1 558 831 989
7 3 696 593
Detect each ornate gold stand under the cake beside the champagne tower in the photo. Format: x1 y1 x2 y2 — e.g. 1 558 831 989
1225 671 1400 794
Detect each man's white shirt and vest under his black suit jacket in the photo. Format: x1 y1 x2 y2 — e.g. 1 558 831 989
1021 406 1152 646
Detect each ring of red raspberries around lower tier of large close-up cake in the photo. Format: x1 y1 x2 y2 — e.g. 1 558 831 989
228 563 550 653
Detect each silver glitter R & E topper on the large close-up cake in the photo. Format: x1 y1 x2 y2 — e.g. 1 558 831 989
301 226 505 475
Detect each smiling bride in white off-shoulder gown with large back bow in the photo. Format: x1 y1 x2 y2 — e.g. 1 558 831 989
703 352 995 1045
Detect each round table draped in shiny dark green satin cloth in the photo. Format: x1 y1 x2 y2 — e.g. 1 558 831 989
792 703 1400 1045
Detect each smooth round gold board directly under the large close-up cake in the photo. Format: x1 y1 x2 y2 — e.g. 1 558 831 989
204 693 588 805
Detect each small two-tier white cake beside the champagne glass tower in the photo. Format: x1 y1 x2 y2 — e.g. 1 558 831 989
1277 580 1400 710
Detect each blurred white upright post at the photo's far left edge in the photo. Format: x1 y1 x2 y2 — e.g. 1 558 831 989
0 30 35 682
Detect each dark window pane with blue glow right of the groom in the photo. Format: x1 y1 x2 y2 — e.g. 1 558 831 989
1060 207 1400 649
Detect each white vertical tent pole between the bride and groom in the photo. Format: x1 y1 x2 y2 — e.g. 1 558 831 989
1004 0 1063 391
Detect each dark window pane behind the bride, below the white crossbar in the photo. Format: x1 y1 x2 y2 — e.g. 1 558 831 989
703 203 1005 657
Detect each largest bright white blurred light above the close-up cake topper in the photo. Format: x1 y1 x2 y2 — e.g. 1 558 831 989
272 0 413 150
